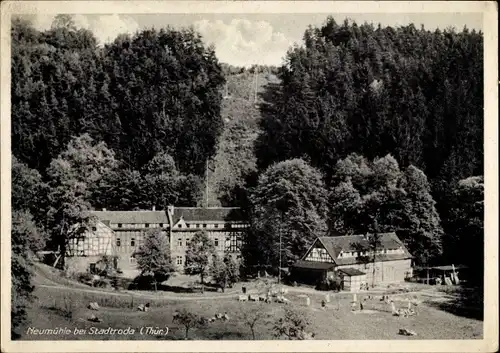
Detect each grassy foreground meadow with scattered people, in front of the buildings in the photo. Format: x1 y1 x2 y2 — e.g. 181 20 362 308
23 266 483 340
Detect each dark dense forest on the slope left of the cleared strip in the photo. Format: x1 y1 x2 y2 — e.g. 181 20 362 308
11 16 224 175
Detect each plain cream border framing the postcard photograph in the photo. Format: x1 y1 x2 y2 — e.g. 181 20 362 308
0 1 498 352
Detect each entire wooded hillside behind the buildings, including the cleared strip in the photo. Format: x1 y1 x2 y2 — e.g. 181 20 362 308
12 15 483 261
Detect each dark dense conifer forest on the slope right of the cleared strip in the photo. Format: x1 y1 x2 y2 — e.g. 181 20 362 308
257 18 483 208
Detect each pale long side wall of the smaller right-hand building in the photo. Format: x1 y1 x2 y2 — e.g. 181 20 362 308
337 259 411 285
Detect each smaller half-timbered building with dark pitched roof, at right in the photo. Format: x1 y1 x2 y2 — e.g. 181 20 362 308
292 233 412 290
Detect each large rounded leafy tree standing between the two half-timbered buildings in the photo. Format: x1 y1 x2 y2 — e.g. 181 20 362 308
246 159 327 268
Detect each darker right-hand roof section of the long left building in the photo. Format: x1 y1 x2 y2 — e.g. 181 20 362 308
172 207 244 224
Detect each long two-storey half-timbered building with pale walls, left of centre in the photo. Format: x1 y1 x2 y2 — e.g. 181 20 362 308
66 206 248 275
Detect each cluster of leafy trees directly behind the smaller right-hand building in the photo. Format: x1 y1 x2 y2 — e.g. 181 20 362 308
330 154 443 264
